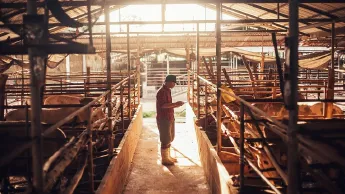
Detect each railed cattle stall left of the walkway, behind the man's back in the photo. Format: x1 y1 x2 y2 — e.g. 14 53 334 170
0 71 141 193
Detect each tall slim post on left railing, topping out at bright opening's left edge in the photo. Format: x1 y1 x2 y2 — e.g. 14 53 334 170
104 5 114 161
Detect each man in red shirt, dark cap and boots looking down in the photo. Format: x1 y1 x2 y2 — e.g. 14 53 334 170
156 75 184 165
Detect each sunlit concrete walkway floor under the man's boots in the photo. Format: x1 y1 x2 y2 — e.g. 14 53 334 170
123 118 211 194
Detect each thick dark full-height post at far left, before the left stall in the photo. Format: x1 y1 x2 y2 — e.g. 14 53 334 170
24 0 47 193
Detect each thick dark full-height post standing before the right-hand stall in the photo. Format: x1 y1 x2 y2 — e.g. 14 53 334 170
285 0 300 194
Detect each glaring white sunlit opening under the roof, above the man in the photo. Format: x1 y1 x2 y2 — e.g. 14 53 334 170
96 4 236 32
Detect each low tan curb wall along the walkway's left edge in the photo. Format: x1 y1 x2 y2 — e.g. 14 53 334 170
96 105 143 194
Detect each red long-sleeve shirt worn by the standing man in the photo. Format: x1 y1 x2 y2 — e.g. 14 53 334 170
156 84 175 121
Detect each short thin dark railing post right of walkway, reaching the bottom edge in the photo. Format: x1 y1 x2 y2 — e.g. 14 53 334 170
240 103 245 193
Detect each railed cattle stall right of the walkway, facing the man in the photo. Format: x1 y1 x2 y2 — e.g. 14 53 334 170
187 49 345 193
